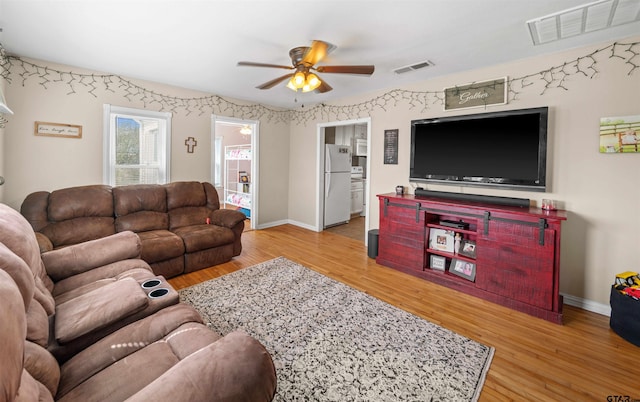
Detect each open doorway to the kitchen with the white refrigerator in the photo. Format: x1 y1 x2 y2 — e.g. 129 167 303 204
316 118 371 244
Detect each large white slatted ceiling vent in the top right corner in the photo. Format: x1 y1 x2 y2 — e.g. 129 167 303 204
527 0 640 45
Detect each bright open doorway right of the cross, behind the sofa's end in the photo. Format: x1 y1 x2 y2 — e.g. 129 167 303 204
211 115 259 229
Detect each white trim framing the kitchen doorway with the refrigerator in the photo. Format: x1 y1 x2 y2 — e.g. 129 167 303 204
315 117 371 245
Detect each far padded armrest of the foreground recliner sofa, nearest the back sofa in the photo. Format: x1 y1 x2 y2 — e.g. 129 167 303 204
42 231 142 282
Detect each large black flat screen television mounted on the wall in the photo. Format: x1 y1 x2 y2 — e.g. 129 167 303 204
409 107 548 191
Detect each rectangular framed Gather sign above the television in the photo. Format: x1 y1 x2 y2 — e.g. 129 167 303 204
444 77 507 110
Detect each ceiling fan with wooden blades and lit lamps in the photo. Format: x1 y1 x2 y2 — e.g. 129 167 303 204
238 40 375 93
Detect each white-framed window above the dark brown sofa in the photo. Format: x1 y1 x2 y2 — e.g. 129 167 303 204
104 105 171 186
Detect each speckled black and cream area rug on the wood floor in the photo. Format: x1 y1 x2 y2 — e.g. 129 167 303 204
180 257 494 401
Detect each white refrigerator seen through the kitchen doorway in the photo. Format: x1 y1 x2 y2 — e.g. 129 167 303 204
324 144 351 228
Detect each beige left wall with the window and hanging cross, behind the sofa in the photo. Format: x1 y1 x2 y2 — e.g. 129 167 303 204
0 61 289 224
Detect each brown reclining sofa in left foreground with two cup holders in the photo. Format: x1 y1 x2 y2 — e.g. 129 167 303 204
0 203 276 402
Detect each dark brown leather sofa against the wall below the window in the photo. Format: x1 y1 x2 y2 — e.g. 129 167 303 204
20 181 245 278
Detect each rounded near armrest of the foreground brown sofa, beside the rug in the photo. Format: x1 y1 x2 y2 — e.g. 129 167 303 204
127 332 276 402
